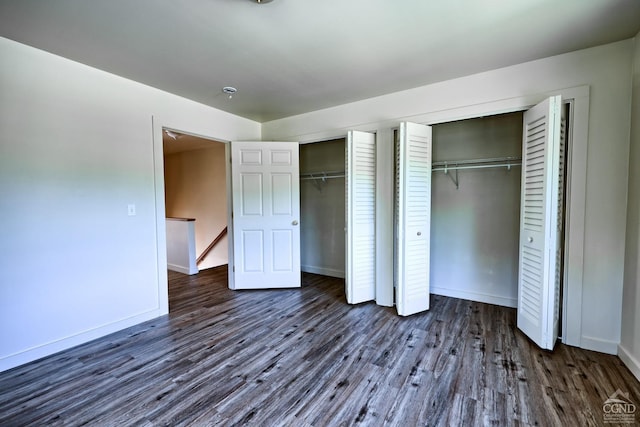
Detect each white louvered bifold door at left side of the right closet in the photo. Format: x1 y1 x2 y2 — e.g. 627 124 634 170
395 123 431 316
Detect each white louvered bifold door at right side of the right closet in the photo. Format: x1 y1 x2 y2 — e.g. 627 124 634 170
518 96 565 350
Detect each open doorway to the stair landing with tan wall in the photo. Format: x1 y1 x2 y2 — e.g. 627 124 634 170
162 128 229 310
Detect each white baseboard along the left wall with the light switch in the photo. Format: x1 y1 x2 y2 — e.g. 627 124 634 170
0 309 167 372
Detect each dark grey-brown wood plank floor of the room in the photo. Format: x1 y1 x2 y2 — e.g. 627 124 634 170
0 268 640 426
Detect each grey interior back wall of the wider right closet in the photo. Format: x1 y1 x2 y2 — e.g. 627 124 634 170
430 112 523 307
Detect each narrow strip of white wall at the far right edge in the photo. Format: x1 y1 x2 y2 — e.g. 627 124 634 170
618 33 640 380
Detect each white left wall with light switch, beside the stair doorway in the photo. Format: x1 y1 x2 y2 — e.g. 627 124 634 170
0 38 260 370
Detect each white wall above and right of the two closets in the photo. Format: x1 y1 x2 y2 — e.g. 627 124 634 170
262 40 633 353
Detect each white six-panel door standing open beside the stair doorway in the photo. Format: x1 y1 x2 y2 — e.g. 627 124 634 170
229 142 300 289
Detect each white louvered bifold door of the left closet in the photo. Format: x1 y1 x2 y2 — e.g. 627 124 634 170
345 131 376 304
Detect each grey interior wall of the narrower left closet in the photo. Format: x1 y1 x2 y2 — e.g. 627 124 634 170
300 139 346 278
